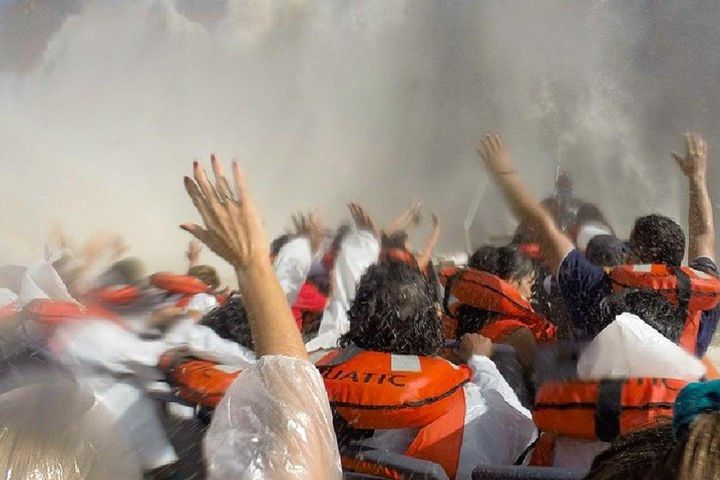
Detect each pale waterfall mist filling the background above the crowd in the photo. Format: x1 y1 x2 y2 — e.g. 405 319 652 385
0 0 720 278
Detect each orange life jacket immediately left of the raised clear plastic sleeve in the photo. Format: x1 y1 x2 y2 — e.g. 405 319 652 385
158 352 241 408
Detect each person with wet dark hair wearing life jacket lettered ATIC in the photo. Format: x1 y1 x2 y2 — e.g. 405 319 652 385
318 261 536 478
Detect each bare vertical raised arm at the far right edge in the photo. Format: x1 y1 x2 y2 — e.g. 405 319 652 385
671 133 715 261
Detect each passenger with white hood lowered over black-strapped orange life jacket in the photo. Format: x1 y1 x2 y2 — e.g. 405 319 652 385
533 289 705 469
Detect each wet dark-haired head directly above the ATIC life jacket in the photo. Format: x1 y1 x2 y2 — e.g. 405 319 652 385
340 262 444 356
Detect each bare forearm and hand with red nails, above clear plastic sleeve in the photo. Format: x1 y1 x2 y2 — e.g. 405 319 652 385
181 157 307 359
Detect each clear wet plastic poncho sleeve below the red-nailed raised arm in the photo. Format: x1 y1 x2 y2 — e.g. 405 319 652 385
204 355 342 480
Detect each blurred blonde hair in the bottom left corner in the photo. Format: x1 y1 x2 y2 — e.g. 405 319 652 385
0 380 140 480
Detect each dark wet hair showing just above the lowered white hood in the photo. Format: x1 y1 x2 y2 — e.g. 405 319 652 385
602 288 685 343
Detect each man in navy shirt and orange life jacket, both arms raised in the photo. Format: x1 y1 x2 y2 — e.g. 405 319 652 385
478 134 720 357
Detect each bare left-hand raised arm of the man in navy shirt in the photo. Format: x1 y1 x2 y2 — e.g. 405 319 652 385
477 134 574 272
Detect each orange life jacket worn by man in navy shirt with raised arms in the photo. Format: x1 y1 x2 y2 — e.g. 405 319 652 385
609 265 720 354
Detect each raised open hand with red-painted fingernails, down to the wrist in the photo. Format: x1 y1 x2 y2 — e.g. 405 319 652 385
181 155 270 271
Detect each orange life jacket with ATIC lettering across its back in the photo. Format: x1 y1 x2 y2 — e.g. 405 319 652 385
317 348 472 478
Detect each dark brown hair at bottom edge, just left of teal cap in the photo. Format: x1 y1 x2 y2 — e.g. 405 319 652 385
585 422 675 480
